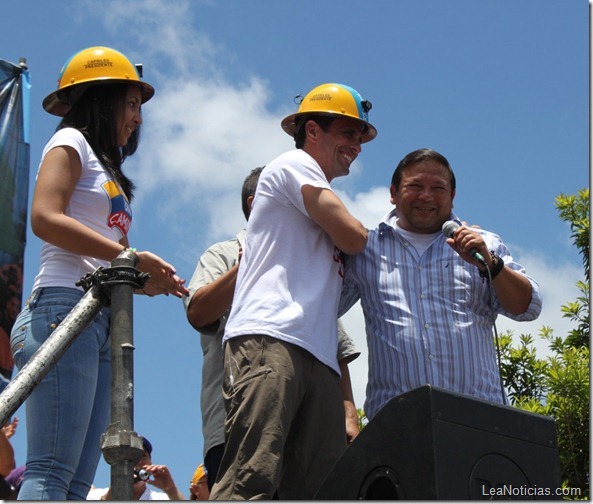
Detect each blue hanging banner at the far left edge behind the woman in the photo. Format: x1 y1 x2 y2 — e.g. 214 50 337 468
0 60 31 391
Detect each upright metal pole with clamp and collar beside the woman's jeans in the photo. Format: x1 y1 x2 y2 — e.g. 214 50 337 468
101 250 146 501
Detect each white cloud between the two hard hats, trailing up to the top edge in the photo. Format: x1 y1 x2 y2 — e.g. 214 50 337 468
105 0 294 249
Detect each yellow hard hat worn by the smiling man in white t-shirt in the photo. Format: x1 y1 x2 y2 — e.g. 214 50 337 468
282 83 377 143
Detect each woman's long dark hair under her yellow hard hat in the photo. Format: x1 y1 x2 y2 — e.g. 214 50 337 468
57 84 140 201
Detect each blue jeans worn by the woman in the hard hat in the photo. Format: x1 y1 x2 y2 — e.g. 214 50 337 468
10 287 111 500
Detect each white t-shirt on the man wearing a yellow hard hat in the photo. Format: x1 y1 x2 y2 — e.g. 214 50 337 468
223 149 343 373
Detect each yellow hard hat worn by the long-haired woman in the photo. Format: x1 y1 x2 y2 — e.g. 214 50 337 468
43 46 154 117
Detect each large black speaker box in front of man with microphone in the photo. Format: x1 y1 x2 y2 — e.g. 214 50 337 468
315 385 560 500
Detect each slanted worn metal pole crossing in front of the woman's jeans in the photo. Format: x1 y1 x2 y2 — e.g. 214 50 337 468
0 286 108 425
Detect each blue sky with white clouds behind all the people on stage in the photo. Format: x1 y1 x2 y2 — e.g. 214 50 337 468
0 0 590 496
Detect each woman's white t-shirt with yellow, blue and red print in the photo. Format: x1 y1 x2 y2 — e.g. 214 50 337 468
33 128 132 290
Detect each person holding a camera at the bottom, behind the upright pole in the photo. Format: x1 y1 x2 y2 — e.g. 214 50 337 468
86 437 185 500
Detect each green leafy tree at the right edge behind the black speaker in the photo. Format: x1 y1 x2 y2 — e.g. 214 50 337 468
499 189 590 499
